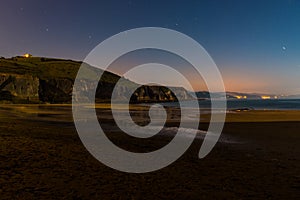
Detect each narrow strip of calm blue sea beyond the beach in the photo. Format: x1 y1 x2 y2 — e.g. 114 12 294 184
166 99 300 110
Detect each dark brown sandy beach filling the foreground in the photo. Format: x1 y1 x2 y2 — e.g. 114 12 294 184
0 105 300 199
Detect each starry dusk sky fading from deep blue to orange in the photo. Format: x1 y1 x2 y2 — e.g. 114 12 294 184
0 0 300 94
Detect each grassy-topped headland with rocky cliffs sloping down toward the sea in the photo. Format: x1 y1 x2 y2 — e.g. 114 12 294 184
0 56 192 103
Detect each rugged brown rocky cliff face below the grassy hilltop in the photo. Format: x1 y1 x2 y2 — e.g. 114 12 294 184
0 74 192 103
